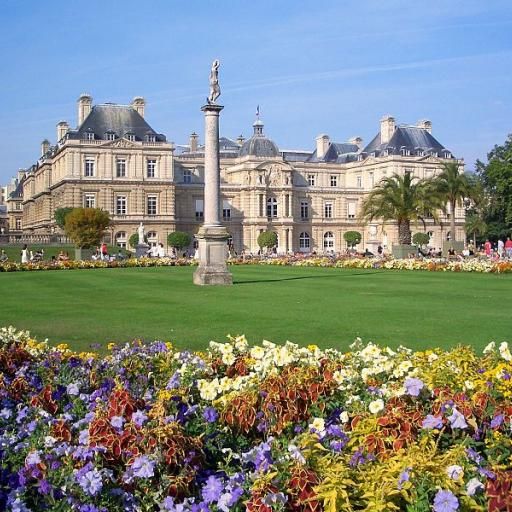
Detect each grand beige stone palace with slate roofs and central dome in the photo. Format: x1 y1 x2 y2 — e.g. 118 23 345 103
6 94 464 253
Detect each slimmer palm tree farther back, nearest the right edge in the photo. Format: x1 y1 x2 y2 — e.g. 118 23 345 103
431 162 471 241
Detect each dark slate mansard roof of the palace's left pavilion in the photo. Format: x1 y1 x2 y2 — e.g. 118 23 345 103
68 103 166 142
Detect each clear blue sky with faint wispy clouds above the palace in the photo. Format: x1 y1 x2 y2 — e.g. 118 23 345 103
0 0 512 183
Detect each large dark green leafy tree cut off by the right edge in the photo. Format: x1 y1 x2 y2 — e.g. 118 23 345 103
476 134 512 240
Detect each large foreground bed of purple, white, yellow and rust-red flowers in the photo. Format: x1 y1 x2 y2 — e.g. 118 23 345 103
0 328 512 512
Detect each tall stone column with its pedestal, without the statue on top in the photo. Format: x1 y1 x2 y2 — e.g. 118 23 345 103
194 102 233 286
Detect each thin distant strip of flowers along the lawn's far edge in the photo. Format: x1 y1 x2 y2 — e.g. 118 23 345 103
0 256 512 274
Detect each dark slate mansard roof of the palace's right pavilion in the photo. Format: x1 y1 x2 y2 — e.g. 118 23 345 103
363 126 446 156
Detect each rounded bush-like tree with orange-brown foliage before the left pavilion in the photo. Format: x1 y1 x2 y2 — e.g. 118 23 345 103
64 208 110 249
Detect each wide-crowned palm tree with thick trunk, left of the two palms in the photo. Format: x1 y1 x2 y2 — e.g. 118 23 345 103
360 172 440 244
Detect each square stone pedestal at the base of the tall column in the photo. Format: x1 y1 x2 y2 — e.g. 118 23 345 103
194 226 233 286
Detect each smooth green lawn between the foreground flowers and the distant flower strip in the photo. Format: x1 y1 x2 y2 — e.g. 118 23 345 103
0 266 512 350
